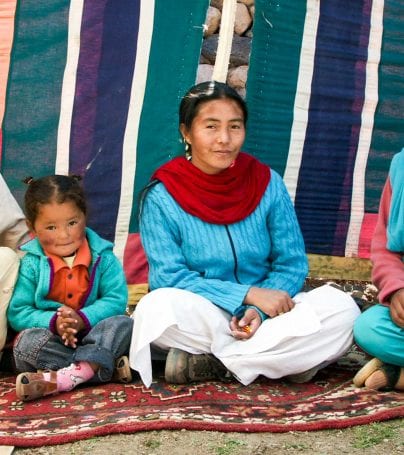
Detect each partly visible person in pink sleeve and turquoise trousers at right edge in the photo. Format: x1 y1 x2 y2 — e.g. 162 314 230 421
353 149 404 390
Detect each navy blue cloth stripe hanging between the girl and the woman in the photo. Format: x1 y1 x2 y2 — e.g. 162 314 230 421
70 0 142 241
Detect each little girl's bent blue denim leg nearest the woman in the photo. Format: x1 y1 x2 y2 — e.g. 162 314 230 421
70 315 133 382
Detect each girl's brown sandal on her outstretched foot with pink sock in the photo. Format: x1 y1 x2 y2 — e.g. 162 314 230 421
15 371 58 401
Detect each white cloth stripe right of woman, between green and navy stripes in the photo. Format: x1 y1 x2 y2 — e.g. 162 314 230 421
283 0 320 201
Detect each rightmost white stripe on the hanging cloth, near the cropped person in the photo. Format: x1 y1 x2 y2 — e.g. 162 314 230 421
345 0 384 257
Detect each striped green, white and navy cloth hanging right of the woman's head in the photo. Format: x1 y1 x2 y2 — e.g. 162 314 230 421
245 0 404 257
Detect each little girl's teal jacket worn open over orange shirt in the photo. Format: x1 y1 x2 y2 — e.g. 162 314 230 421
7 228 128 332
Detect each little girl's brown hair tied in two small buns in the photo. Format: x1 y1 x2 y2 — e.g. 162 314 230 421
24 175 87 226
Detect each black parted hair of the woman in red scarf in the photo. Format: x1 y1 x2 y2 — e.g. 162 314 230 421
179 81 248 130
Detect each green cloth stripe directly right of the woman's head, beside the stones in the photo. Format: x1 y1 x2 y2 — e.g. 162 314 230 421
244 0 306 175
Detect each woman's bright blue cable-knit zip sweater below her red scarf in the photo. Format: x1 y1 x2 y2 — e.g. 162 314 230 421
140 170 308 318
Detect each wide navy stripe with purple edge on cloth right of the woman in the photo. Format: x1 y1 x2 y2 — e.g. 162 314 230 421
295 0 370 256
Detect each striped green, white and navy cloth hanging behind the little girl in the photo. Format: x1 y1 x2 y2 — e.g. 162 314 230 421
0 0 209 283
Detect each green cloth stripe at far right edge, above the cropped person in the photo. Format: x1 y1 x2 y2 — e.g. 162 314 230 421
365 0 404 213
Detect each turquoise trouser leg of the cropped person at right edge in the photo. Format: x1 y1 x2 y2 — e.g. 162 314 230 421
354 305 404 367
